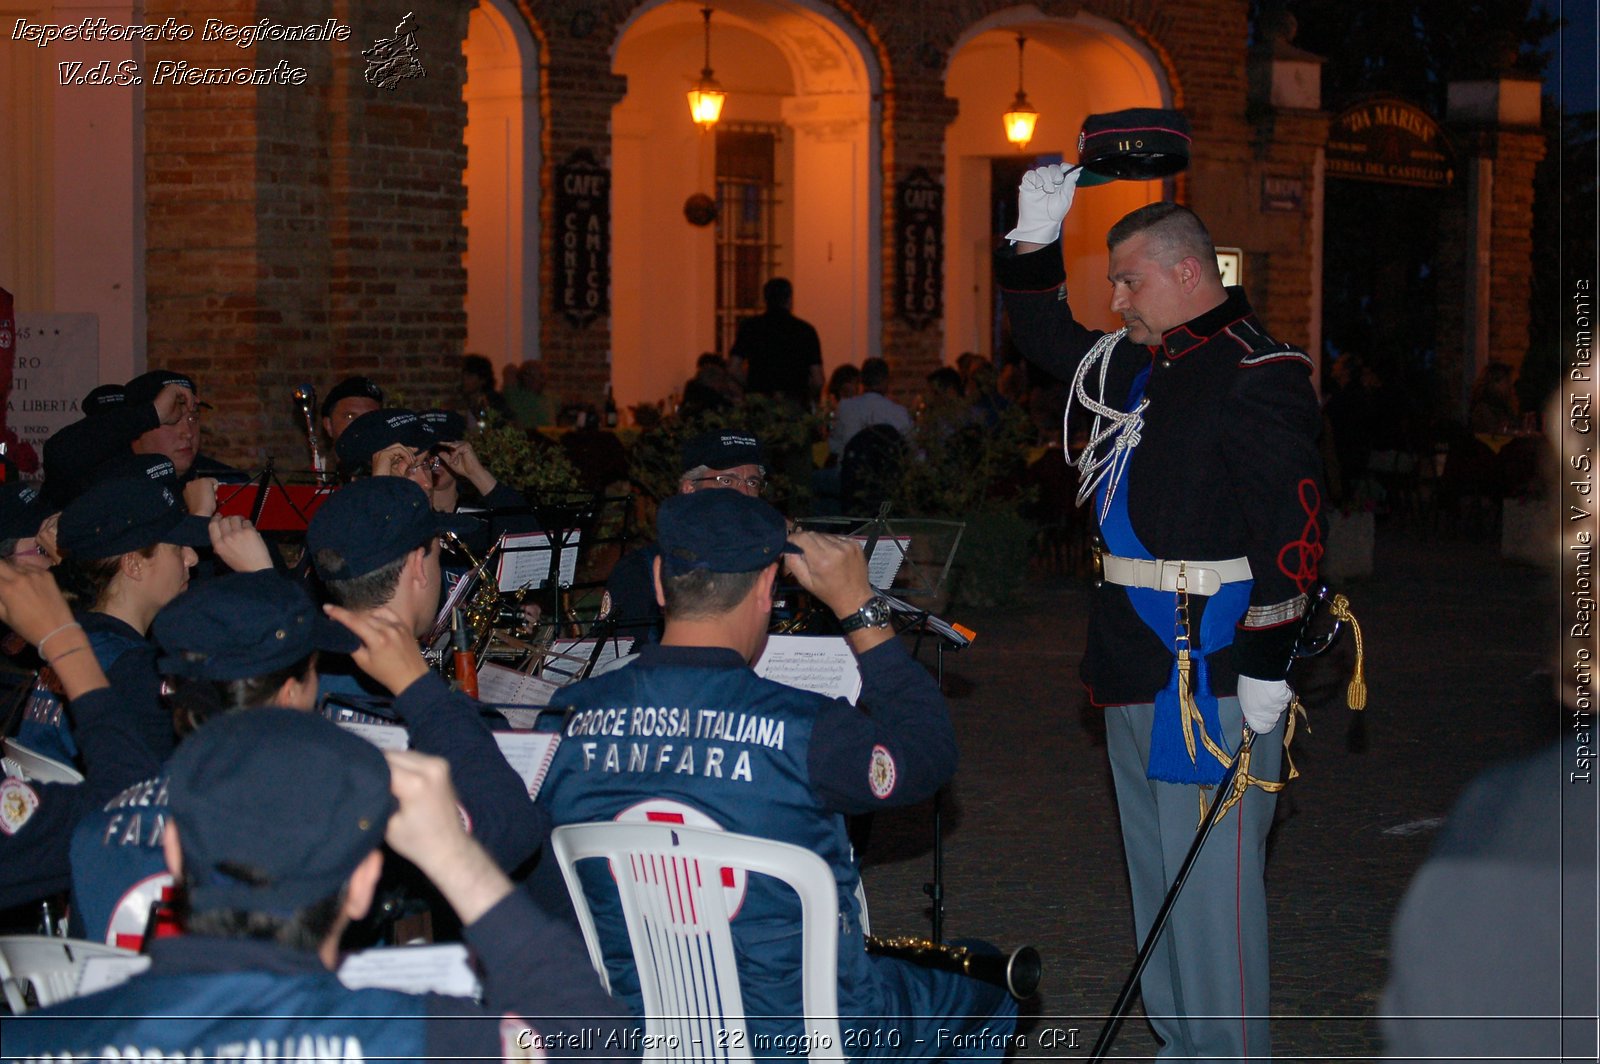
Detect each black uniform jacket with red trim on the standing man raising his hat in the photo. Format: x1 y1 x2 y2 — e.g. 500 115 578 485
995 245 1323 706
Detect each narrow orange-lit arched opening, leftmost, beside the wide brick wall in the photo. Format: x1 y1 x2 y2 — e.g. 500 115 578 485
462 0 539 366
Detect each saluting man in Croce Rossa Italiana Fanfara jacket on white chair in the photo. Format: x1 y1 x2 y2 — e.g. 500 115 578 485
539 491 1016 1058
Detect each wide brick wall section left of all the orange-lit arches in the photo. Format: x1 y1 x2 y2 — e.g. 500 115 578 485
146 0 466 467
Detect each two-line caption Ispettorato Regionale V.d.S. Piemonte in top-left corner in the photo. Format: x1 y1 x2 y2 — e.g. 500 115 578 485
10 18 350 85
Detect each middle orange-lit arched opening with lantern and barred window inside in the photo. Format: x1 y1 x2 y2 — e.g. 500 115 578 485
611 0 882 405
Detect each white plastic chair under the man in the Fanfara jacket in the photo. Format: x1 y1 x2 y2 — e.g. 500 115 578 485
550 822 845 1062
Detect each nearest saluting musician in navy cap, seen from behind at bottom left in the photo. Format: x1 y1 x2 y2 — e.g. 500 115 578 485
14 709 629 1061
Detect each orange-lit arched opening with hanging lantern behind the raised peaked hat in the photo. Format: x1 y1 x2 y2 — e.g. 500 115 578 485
944 10 1171 362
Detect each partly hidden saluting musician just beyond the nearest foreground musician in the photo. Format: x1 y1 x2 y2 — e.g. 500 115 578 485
72 570 541 949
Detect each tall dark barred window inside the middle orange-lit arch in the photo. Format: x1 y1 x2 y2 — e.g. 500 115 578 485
717 125 782 355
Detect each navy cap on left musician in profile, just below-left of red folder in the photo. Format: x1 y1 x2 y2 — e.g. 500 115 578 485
56 477 211 560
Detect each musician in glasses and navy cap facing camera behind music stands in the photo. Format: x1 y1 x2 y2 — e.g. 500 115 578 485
603 429 766 646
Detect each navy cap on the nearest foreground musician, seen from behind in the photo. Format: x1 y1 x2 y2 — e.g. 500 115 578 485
166 707 395 915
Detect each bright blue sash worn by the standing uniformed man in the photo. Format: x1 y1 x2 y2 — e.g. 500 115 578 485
1094 366 1253 786
